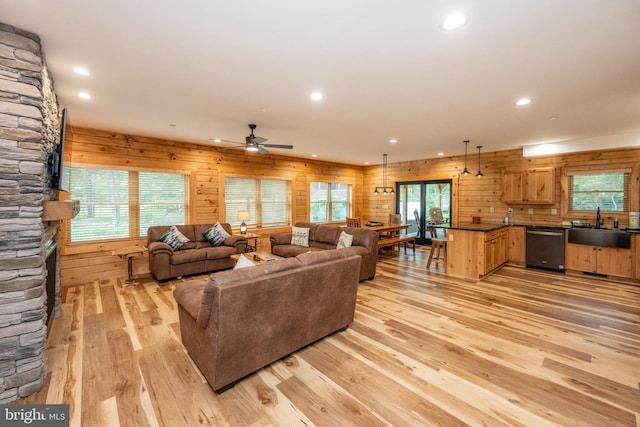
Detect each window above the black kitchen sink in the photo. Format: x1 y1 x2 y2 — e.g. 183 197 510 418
567 171 629 212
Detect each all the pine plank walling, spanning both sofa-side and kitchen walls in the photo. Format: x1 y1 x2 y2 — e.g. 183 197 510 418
61 128 640 286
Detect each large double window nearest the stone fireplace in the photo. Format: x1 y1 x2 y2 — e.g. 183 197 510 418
67 168 189 242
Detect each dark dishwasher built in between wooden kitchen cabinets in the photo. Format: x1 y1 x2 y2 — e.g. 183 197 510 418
526 226 565 272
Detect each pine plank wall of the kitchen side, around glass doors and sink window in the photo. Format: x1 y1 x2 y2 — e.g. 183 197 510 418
364 148 640 227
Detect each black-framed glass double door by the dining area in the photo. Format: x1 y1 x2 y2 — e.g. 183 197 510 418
396 179 451 245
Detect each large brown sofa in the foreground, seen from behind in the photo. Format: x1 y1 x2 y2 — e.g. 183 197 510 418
174 249 361 393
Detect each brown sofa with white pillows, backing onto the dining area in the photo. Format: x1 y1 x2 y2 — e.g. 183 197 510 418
269 222 378 281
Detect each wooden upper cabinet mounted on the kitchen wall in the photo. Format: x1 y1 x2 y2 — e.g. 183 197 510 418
502 167 555 204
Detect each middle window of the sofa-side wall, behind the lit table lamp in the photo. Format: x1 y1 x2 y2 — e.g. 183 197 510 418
224 177 291 227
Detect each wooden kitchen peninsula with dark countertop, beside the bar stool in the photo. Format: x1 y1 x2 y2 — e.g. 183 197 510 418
447 223 509 280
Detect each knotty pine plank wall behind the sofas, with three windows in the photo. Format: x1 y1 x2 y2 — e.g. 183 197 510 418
61 128 363 286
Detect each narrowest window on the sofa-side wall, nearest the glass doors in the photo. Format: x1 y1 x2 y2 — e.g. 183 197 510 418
309 182 351 222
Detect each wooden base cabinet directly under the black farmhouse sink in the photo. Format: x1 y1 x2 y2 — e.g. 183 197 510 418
565 243 633 278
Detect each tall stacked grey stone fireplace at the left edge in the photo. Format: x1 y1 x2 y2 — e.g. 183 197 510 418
0 23 60 403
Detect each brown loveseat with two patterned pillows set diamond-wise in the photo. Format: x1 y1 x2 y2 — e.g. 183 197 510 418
147 223 247 281
